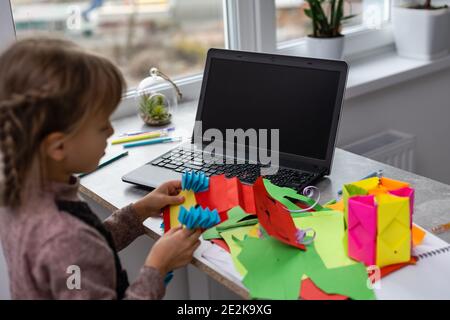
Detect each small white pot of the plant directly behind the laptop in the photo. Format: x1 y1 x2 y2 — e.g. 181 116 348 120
306 36 344 60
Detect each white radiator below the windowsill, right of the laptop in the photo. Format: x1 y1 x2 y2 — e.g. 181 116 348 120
341 130 416 172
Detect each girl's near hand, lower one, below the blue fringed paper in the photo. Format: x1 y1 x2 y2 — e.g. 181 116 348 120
145 226 202 277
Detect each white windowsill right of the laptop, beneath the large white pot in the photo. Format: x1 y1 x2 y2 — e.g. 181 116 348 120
345 50 450 99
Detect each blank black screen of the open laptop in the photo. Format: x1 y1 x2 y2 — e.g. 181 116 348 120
200 58 340 160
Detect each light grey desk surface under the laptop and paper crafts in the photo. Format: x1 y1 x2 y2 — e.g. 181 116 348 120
81 101 450 298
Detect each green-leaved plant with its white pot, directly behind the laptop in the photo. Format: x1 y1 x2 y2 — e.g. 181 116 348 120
304 0 355 59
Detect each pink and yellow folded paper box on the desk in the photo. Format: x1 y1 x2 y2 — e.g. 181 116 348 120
343 177 414 267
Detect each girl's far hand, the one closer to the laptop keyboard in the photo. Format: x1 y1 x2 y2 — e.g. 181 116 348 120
133 180 184 221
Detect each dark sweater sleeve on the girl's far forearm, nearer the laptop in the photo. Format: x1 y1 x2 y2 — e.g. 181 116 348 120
103 204 145 251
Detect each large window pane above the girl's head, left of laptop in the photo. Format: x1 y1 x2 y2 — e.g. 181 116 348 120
11 0 225 87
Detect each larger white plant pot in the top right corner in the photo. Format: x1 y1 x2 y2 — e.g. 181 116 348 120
392 7 450 60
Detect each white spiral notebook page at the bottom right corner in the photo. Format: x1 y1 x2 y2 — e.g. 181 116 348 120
375 228 450 300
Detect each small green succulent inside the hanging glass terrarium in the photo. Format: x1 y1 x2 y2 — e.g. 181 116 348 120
139 94 171 125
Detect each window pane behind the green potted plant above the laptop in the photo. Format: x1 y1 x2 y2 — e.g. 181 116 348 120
275 0 389 42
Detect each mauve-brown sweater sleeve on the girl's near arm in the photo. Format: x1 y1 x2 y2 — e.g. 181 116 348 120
33 228 165 299
